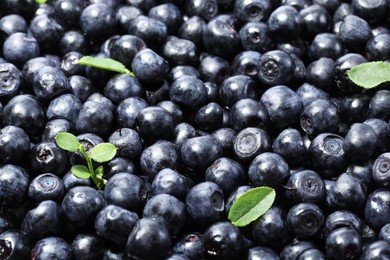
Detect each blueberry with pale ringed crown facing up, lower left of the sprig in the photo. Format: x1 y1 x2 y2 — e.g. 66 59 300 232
28 173 65 203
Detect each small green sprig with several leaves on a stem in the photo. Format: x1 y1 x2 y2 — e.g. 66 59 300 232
55 132 117 189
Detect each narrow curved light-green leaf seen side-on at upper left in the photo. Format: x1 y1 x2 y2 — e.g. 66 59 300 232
77 56 135 77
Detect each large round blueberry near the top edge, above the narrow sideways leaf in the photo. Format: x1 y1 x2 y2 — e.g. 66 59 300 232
80 3 116 40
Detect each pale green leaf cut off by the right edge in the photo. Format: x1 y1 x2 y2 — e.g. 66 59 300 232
348 61 390 89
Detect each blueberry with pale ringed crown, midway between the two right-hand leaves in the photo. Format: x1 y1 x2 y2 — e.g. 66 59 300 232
309 133 347 177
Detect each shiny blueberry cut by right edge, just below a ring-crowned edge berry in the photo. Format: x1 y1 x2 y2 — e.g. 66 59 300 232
364 188 390 229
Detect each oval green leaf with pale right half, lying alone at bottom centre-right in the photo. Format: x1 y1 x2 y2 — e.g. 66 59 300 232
228 186 276 227
